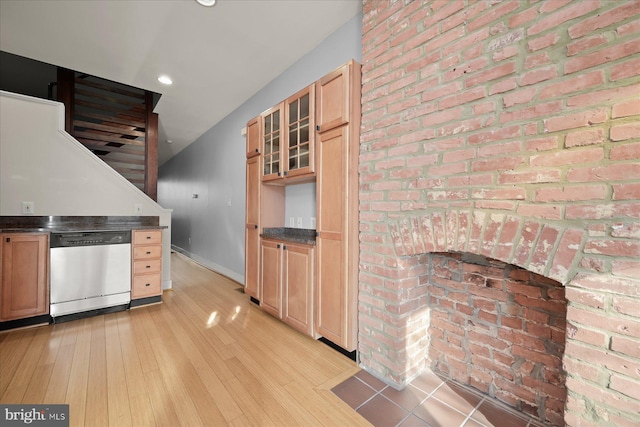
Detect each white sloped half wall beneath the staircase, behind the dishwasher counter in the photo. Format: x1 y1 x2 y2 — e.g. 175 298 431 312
0 91 171 289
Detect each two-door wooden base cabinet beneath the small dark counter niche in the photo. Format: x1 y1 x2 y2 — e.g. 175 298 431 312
260 239 317 338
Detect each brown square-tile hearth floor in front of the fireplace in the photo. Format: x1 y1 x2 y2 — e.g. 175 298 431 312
331 371 543 427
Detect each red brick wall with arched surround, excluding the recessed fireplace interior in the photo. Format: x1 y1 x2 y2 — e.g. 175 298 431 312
359 0 640 426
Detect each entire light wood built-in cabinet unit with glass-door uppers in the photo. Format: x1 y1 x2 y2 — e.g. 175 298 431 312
245 60 361 351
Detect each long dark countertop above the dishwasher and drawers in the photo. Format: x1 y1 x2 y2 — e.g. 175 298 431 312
0 216 167 233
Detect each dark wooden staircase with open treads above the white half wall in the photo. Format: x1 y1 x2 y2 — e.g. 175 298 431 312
58 68 158 201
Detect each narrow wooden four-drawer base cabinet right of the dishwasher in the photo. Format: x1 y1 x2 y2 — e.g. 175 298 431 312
131 230 162 300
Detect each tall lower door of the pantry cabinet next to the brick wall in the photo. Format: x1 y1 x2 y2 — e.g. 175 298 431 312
315 127 348 346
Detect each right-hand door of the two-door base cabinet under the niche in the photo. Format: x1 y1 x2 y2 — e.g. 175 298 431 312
282 243 315 336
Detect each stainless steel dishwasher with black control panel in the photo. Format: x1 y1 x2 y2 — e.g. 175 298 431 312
50 231 131 321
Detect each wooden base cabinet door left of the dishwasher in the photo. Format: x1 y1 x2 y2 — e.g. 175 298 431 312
0 233 49 321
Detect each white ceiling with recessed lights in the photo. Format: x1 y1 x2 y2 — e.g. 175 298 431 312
0 0 362 164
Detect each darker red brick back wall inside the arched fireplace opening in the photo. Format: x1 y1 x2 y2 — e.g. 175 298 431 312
428 253 567 425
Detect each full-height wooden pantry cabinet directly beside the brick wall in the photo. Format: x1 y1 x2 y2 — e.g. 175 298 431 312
315 61 361 351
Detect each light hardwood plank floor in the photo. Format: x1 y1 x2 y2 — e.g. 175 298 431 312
0 254 370 427
